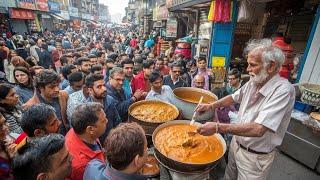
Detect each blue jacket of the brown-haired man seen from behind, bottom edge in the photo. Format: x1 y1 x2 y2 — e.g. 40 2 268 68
83 159 147 180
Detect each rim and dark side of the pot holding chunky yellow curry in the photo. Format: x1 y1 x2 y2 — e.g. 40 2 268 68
128 100 179 136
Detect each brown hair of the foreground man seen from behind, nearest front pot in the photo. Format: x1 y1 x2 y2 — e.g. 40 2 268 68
105 123 145 170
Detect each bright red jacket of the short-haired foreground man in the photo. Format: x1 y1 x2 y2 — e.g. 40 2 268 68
65 129 105 180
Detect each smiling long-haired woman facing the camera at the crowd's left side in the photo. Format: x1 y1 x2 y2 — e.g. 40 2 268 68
13 67 34 103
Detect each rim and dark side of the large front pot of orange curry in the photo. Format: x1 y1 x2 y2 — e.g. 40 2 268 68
152 120 227 173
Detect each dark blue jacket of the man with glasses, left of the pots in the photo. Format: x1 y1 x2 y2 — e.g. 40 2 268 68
106 82 133 121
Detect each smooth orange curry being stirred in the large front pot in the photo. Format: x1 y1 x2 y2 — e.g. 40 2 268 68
155 124 223 164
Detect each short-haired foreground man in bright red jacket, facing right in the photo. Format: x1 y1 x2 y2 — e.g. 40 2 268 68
65 103 108 180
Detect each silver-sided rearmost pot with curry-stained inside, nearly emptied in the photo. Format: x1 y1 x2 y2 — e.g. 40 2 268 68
173 87 218 121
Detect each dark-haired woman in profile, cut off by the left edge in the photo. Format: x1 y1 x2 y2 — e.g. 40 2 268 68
0 83 22 134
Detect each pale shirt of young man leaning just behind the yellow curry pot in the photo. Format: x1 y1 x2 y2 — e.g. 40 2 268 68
146 85 175 104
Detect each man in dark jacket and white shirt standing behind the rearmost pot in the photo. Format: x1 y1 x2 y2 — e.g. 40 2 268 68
163 61 188 90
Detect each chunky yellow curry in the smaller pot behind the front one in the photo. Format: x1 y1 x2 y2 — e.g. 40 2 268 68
130 102 179 123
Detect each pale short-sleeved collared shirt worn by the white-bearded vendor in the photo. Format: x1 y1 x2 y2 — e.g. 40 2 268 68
232 75 295 153
